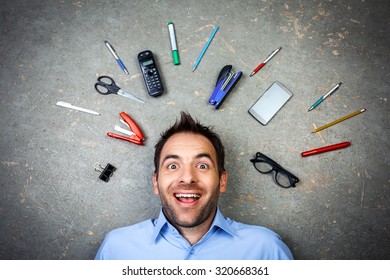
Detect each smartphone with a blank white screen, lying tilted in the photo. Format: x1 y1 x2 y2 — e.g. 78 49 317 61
248 81 293 125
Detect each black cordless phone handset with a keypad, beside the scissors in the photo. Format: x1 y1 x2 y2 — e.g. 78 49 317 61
138 50 164 97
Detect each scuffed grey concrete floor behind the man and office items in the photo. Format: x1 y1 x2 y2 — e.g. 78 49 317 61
0 0 390 259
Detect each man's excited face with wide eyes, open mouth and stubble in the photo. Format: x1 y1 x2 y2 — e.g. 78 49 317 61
153 133 227 228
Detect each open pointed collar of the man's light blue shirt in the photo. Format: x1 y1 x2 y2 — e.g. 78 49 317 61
152 208 238 241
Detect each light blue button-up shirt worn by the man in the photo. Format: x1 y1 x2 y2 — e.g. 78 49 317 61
95 209 293 260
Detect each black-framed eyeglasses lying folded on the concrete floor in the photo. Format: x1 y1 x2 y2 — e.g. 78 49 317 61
250 152 299 188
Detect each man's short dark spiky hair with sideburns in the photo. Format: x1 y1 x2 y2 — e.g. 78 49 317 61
154 112 225 175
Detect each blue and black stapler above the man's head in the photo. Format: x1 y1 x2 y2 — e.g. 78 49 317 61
209 65 242 109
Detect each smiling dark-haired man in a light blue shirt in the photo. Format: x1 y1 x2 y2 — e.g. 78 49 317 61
95 112 293 260
